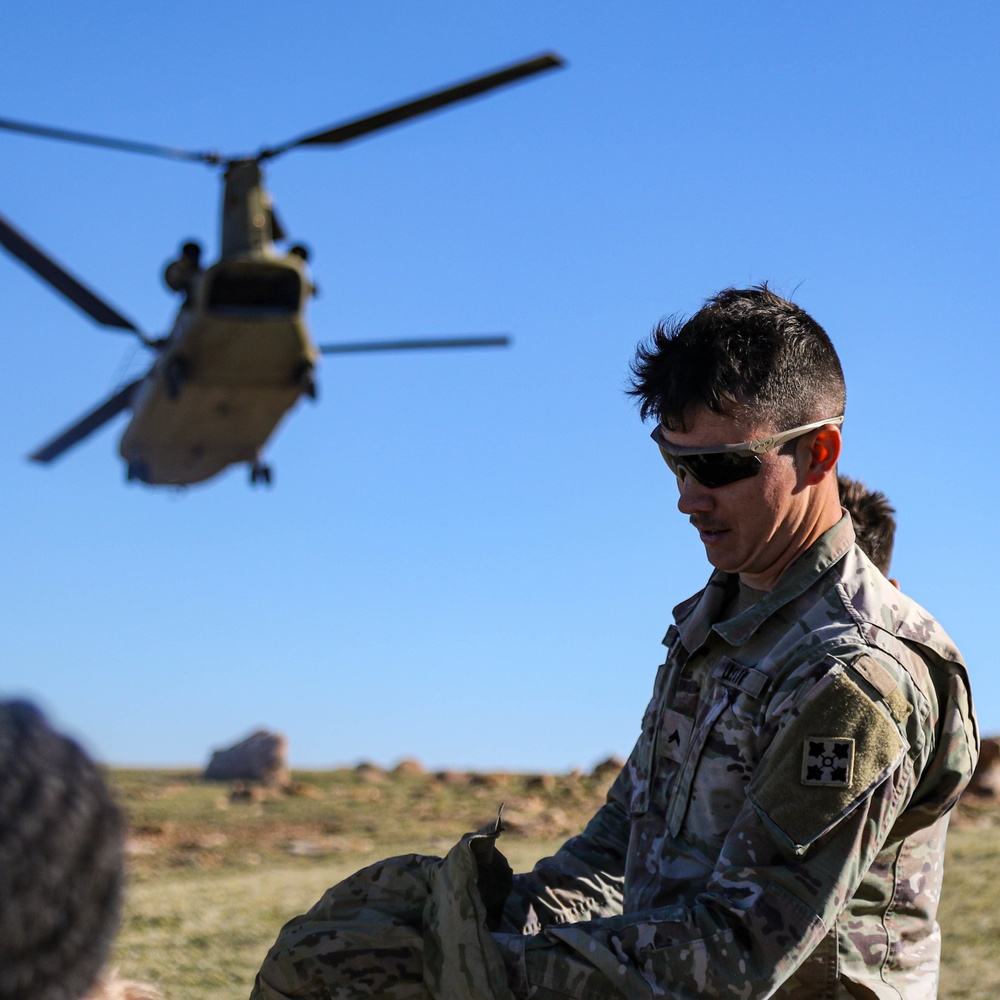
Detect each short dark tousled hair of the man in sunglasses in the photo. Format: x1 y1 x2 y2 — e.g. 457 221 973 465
626 284 847 431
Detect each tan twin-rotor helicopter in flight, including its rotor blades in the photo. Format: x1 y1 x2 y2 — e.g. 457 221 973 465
0 54 562 486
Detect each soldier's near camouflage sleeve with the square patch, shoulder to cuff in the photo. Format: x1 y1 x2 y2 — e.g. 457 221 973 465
497 666 913 1000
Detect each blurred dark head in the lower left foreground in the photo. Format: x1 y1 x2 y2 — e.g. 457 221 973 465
0 701 123 1000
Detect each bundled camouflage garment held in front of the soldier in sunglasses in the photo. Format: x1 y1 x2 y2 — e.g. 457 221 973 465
250 819 513 1000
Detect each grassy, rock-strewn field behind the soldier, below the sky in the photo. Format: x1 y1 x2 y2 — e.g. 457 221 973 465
105 767 1000 1000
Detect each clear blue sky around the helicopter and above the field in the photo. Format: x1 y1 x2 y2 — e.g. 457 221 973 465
0 0 1000 770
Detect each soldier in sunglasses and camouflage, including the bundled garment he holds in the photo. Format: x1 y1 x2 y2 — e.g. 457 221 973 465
253 287 978 1000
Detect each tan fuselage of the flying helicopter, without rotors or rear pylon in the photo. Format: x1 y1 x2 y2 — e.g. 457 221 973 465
119 252 318 486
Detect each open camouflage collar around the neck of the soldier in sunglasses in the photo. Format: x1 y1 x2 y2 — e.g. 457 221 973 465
674 512 854 653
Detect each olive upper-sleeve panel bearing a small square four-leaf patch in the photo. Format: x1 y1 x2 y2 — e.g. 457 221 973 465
747 671 906 854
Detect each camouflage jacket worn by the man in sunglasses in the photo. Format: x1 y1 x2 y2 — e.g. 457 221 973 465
494 515 978 1000
